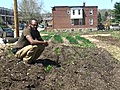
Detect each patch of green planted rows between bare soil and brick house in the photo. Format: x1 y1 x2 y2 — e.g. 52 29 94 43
42 32 94 47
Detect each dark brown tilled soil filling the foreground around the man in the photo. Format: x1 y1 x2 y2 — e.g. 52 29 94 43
0 37 120 90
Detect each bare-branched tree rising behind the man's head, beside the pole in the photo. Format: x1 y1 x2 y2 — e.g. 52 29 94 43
18 0 44 21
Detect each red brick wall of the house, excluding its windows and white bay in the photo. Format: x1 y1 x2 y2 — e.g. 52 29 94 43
52 6 98 29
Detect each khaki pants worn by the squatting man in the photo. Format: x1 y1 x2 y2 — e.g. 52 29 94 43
15 45 45 63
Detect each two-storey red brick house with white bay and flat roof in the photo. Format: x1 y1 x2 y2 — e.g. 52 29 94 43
52 3 98 31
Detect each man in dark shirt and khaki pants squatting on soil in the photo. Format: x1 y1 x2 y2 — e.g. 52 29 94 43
15 19 48 63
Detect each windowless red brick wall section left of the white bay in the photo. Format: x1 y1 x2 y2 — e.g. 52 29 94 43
52 7 71 29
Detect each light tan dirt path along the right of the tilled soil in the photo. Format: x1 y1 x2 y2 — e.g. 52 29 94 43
82 34 120 61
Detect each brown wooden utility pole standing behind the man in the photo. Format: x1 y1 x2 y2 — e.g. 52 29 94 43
14 0 19 37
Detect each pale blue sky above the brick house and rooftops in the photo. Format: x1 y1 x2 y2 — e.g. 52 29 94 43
0 0 120 12
